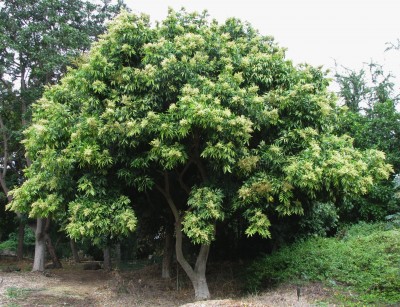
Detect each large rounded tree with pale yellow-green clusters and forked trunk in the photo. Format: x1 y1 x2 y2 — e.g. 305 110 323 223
10 10 391 299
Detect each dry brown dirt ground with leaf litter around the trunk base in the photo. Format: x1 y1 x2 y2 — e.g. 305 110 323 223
0 261 333 307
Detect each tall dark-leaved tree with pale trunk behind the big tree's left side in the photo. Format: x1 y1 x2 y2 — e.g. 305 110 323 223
0 0 124 271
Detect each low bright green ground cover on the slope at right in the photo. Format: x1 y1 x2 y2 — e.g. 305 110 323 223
247 223 400 305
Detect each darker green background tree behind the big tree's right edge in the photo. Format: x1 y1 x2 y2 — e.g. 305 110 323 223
336 63 400 221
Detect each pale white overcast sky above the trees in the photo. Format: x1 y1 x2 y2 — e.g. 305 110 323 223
126 0 400 92
